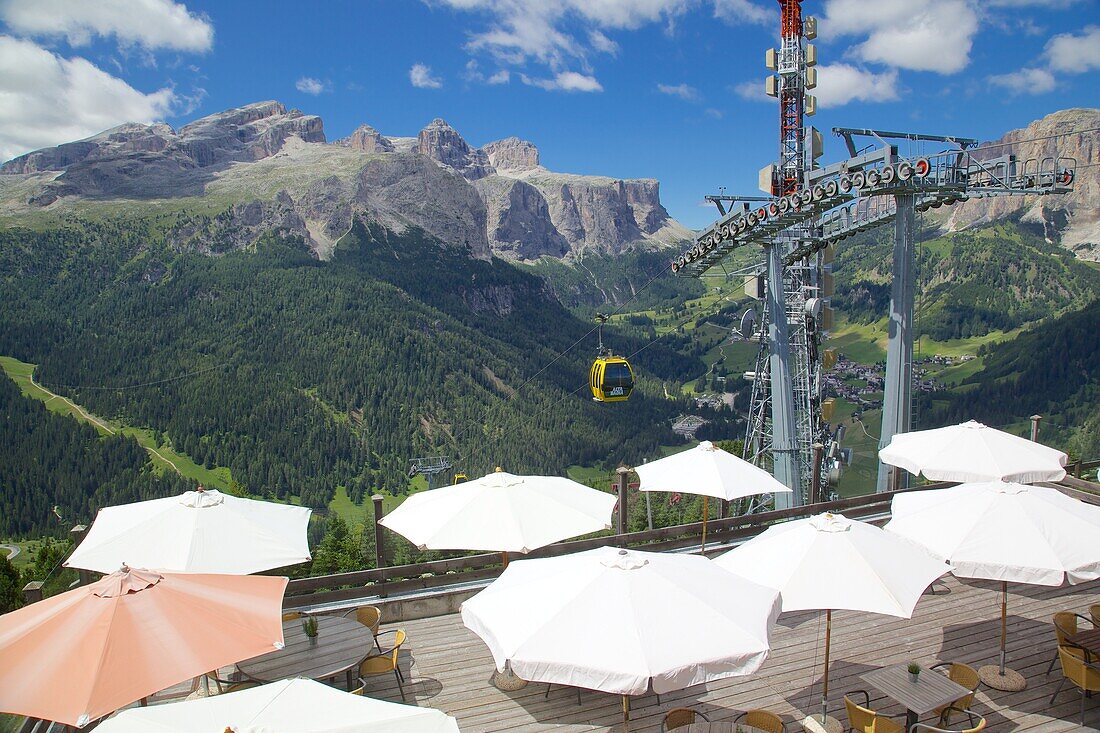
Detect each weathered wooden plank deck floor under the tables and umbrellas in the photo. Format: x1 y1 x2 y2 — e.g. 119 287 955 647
354 576 1100 733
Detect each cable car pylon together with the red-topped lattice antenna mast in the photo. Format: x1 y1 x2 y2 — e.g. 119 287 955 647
672 0 1077 508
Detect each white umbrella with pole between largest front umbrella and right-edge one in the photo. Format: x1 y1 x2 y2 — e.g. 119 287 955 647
714 514 950 727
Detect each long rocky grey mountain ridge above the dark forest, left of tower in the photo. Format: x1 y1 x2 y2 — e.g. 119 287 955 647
0 101 691 261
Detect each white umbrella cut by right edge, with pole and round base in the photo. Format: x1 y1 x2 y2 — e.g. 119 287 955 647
886 481 1100 690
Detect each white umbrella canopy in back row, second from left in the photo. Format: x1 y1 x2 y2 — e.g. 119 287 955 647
382 471 615 553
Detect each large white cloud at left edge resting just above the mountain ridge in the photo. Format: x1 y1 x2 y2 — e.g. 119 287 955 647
0 35 179 160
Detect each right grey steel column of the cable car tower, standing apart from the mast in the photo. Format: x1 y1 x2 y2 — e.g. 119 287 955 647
877 194 916 493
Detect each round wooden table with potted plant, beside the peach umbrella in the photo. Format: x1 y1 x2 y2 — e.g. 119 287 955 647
237 616 375 690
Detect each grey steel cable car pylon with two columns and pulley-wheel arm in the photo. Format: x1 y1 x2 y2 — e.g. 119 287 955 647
672 121 1077 501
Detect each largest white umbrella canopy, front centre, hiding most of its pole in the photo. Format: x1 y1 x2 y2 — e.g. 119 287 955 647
462 547 779 694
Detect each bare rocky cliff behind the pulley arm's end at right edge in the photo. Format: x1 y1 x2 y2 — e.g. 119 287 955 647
942 109 1100 261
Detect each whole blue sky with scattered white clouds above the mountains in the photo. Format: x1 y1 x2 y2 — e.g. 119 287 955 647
0 0 1100 227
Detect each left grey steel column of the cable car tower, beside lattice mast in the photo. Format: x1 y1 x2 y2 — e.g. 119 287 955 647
767 244 802 501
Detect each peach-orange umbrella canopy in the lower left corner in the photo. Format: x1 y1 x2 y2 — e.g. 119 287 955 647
0 568 287 727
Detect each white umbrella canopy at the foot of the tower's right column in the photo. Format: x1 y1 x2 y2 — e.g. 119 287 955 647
879 420 1067 483
